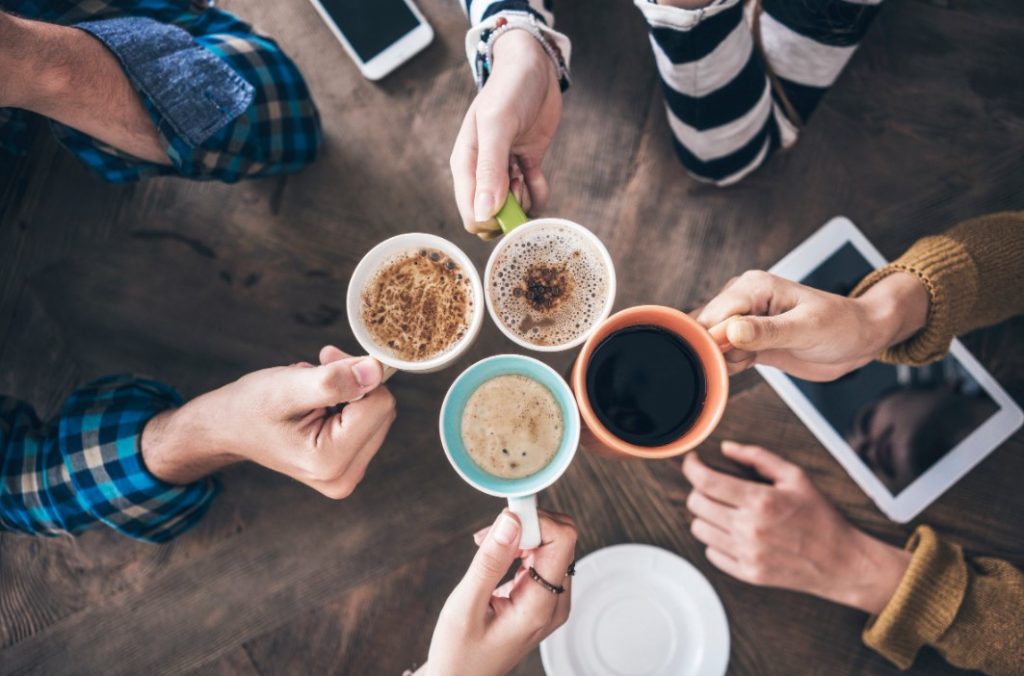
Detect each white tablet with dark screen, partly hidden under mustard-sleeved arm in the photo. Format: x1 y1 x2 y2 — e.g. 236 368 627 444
757 217 1024 523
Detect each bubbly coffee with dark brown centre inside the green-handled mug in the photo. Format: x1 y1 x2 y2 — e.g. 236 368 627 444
487 224 608 346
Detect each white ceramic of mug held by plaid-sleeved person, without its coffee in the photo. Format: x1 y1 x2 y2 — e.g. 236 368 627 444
346 233 484 380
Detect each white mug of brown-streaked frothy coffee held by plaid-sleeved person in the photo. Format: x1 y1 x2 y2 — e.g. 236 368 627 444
346 233 484 376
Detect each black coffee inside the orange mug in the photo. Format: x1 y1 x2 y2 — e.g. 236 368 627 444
587 326 708 447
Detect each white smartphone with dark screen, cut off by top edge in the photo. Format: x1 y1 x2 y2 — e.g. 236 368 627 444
309 0 434 80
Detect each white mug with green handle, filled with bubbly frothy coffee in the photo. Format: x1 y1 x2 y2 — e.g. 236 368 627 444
483 194 615 352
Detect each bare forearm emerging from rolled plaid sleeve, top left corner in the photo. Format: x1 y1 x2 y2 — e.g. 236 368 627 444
0 12 170 165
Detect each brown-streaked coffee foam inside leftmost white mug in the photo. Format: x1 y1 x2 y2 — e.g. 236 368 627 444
361 248 474 362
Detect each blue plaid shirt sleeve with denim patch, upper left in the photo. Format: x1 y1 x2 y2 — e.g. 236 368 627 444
0 0 321 182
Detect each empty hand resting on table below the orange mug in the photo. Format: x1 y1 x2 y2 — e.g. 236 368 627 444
683 441 910 615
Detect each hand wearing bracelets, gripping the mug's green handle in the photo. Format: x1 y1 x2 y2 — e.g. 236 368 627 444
451 30 562 239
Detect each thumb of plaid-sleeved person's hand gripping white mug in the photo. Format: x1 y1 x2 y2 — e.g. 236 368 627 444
282 356 383 411
